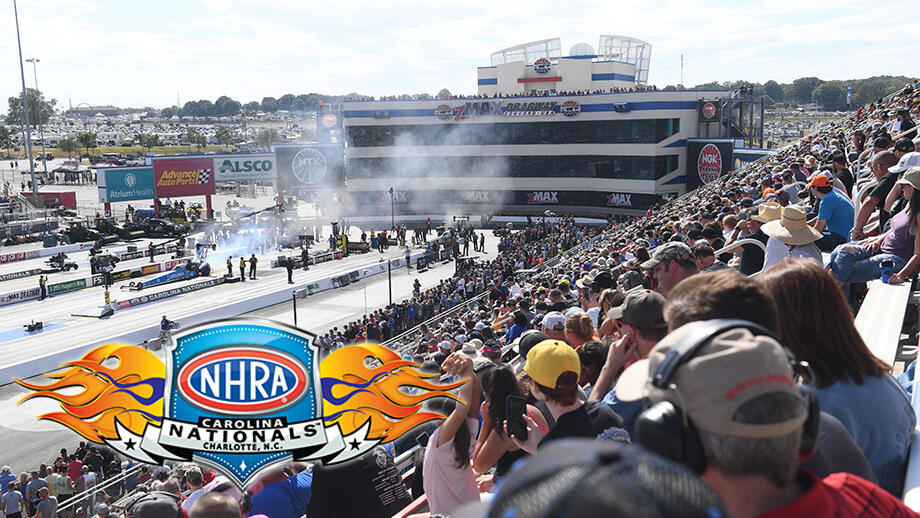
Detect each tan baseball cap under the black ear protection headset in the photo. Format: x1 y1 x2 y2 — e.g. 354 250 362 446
616 322 808 438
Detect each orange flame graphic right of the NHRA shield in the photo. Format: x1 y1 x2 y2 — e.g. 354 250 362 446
320 343 465 442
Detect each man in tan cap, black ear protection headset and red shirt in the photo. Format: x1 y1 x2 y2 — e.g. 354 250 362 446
616 319 915 518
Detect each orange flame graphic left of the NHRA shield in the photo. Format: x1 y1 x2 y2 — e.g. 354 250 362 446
15 344 166 443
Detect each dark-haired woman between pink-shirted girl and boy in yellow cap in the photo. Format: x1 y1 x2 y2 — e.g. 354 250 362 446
473 365 549 489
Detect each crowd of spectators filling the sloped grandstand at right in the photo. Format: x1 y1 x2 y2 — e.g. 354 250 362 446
7 78 920 518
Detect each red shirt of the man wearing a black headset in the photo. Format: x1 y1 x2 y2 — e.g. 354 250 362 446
759 470 920 518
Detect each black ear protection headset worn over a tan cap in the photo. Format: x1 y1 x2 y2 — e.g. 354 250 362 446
635 318 821 474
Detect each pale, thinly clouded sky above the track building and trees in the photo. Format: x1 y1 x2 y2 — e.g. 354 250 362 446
0 0 920 111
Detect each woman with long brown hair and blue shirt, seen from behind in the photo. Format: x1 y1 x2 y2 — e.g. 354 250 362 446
758 261 916 495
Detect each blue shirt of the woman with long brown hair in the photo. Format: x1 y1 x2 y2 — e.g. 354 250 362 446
815 374 917 493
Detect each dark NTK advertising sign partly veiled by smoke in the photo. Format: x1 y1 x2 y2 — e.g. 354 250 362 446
275 144 345 191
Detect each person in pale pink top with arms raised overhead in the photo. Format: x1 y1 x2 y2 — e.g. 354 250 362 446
422 351 481 514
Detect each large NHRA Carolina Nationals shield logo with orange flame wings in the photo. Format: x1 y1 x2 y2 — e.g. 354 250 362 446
19 318 467 494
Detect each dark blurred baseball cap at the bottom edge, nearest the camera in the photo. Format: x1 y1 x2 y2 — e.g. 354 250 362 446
478 439 728 518
